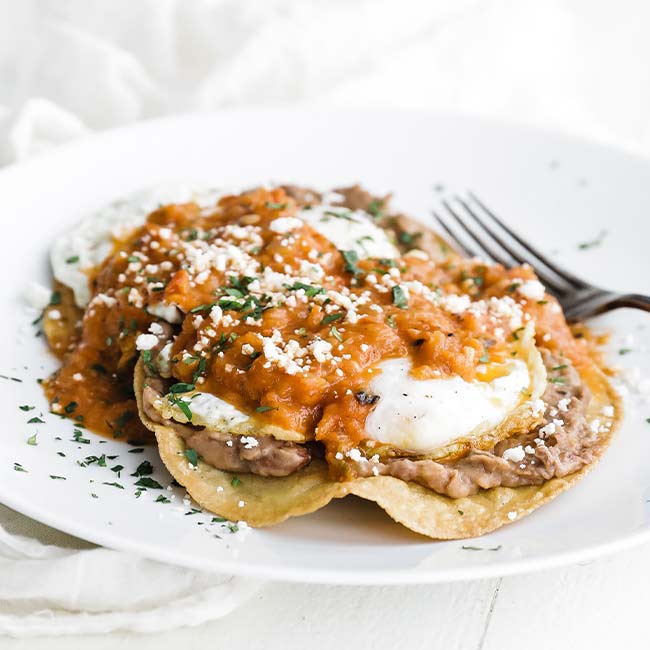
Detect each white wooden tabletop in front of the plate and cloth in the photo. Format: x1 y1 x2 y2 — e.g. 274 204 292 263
0 546 650 650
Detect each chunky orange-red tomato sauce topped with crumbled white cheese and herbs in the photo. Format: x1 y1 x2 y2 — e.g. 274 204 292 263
40 189 587 445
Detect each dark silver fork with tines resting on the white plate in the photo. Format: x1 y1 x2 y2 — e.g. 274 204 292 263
433 192 650 321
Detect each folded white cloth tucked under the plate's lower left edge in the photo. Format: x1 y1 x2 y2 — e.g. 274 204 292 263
0 506 259 637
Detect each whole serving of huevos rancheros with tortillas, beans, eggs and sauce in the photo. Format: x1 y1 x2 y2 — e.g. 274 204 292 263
44 186 618 538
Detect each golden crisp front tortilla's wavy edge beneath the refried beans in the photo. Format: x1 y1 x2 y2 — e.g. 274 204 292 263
135 362 621 539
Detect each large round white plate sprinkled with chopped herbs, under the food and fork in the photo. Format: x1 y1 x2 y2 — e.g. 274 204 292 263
0 111 650 584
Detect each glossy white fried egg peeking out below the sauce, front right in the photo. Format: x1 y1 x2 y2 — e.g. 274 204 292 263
365 359 531 453
